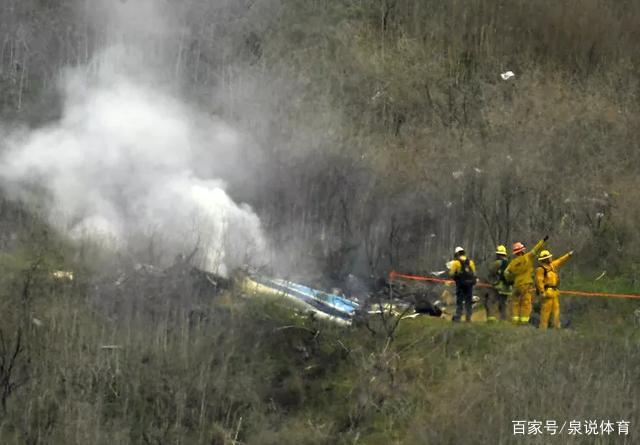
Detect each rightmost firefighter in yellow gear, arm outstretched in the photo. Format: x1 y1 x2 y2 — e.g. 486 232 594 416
536 250 573 329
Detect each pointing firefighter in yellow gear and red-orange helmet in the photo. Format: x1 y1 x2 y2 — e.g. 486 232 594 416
504 236 549 324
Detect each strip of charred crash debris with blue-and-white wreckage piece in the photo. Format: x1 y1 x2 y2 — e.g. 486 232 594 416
92 253 453 325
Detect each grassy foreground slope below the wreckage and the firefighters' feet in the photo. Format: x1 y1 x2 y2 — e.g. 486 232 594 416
0 227 640 445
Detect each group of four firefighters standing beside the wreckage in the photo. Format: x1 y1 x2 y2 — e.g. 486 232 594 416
449 236 573 329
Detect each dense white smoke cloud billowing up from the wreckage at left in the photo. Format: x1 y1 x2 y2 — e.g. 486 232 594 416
0 2 266 274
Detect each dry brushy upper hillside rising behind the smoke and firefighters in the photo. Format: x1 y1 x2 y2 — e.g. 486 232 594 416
0 0 640 279
